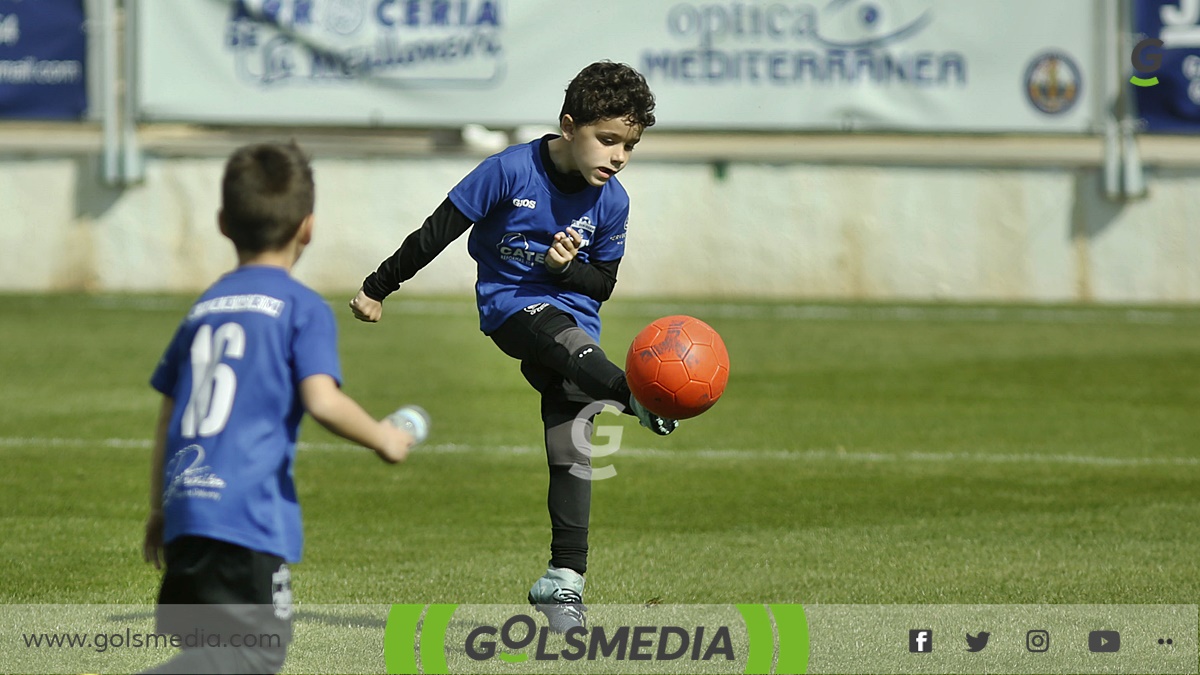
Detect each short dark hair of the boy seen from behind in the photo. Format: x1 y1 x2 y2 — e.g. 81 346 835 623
221 142 314 252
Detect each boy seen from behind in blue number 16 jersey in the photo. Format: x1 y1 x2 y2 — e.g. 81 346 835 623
143 144 428 673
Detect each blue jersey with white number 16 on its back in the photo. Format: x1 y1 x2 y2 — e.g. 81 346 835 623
150 265 341 562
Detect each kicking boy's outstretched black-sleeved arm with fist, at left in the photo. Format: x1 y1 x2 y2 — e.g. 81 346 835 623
350 197 474 321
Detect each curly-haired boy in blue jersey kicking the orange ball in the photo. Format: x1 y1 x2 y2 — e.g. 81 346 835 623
350 61 678 632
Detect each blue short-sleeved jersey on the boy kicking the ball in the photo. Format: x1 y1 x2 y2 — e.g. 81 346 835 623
450 138 629 341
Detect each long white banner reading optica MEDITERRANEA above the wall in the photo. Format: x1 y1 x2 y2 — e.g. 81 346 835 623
138 0 1097 132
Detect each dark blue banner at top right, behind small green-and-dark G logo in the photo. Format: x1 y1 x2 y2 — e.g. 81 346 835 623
1128 0 1200 133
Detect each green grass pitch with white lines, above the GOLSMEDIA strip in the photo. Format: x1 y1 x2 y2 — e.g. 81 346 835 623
0 294 1200 667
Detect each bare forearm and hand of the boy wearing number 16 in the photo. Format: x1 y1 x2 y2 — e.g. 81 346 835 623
300 375 415 464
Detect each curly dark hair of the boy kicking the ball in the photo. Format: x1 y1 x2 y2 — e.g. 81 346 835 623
558 61 654 129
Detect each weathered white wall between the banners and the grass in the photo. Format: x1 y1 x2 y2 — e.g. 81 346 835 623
7 142 1200 303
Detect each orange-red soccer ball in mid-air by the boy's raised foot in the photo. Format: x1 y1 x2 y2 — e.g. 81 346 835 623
625 315 730 419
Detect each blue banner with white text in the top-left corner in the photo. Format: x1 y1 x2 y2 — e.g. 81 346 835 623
0 0 88 119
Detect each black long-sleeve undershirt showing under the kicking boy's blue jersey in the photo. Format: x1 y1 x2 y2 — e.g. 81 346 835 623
362 137 620 303
